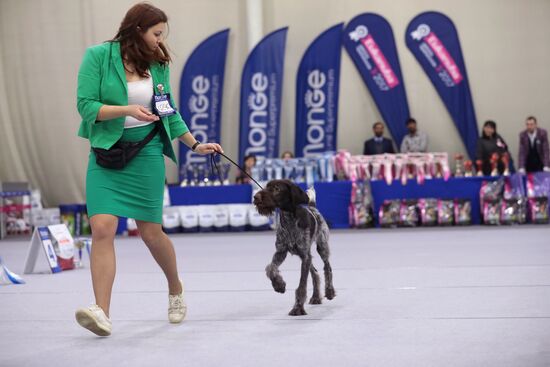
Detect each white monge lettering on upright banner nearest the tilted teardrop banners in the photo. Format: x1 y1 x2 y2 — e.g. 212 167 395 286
303 69 327 156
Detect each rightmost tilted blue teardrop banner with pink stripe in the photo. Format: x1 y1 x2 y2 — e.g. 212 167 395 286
405 12 478 159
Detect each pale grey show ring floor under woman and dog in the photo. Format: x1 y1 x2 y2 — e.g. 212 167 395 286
0 226 550 367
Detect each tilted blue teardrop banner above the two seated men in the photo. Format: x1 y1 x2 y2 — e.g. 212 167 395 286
344 13 410 147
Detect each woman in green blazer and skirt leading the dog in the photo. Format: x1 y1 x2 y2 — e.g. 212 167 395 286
76 3 223 336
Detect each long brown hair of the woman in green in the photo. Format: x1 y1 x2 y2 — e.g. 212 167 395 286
111 3 171 78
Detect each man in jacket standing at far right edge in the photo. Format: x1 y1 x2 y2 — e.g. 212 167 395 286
518 116 550 173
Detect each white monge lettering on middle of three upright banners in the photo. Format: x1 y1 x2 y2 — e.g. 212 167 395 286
245 72 269 157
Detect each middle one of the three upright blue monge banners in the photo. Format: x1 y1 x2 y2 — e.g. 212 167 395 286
239 27 288 162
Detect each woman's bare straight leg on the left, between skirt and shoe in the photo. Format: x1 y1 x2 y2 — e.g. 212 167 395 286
90 214 118 317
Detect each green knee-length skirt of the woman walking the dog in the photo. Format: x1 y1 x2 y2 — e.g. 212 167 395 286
86 123 165 223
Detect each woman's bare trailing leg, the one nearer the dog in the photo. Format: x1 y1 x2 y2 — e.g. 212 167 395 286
136 221 182 295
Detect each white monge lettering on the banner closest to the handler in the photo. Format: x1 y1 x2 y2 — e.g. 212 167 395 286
186 75 210 163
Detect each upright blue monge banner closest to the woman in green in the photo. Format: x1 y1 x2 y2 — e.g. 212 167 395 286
179 29 229 175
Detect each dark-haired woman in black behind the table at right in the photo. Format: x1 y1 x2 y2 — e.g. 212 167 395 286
476 120 512 176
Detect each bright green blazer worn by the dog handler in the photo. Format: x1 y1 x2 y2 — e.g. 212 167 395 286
76 42 189 162
